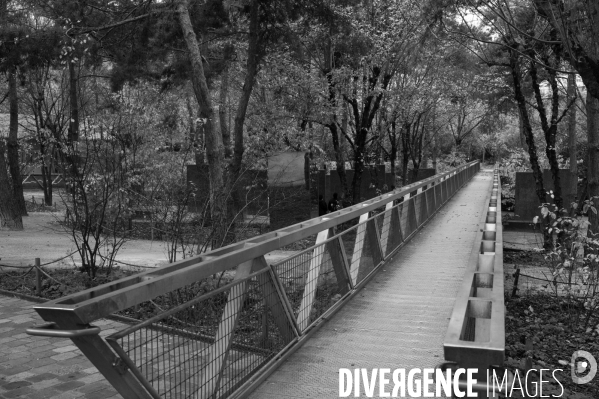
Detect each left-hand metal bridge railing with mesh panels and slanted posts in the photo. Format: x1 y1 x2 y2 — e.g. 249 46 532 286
30 162 480 399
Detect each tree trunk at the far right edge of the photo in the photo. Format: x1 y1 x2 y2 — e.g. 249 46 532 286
581 93 599 233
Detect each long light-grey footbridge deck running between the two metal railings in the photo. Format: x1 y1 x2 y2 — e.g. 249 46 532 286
251 170 493 399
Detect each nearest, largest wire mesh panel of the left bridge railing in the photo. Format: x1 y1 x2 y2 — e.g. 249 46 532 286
107 269 294 399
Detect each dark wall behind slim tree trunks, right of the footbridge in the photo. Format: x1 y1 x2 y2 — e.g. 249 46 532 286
514 169 576 220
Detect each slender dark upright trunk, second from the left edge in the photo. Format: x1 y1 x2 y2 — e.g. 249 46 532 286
6 69 27 216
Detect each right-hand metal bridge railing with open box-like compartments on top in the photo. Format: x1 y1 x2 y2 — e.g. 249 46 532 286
443 169 509 397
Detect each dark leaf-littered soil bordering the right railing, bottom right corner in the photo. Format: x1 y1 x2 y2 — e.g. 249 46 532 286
504 251 599 399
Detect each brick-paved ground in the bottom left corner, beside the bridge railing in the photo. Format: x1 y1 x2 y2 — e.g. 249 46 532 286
0 296 121 399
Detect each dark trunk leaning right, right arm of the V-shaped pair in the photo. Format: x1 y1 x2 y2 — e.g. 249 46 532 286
231 0 262 181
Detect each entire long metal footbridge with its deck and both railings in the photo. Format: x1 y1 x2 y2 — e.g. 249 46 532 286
28 162 505 399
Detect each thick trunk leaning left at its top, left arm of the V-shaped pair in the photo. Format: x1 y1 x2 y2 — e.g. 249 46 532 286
177 0 227 247
